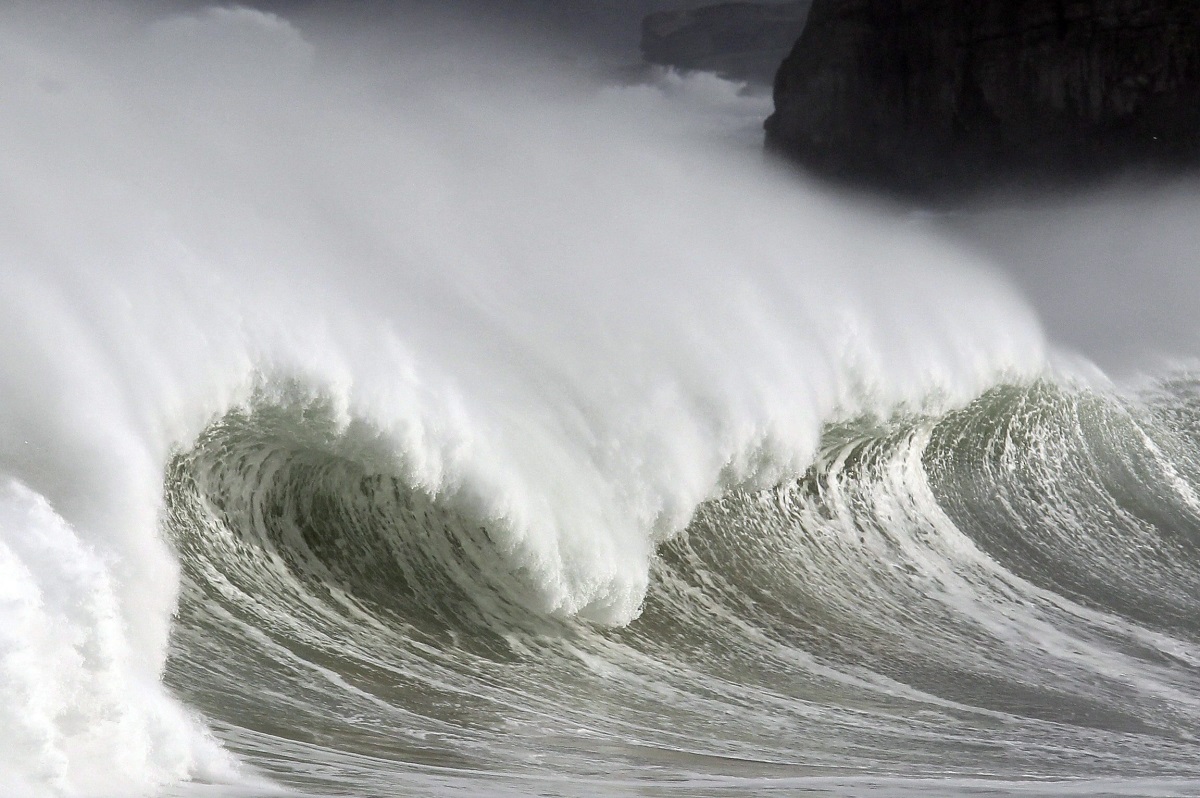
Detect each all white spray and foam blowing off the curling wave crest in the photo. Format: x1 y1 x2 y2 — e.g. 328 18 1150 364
0 4 1089 794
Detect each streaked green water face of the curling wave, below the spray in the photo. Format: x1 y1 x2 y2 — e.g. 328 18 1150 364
167 378 1200 794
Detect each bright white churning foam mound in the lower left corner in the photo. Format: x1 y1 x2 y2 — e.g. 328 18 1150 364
0 480 232 796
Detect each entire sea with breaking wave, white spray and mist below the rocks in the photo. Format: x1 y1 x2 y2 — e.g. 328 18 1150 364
7 2 1200 798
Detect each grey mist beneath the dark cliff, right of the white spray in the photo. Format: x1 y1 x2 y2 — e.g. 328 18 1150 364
944 184 1200 378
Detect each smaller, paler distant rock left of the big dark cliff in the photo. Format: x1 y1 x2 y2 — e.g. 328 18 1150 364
642 0 811 84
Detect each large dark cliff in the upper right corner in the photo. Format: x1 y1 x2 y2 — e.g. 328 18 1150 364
766 0 1200 193
